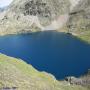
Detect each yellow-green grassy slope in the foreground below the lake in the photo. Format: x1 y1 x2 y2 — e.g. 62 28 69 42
0 54 90 90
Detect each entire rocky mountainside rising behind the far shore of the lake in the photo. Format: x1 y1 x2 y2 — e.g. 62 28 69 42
0 0 90 38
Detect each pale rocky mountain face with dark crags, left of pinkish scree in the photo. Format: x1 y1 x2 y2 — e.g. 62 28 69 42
0 0 70 34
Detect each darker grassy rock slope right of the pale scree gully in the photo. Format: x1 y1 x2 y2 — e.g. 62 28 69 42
67 0 90 34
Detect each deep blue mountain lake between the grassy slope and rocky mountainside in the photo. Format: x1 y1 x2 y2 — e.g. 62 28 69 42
0 31 90 79
